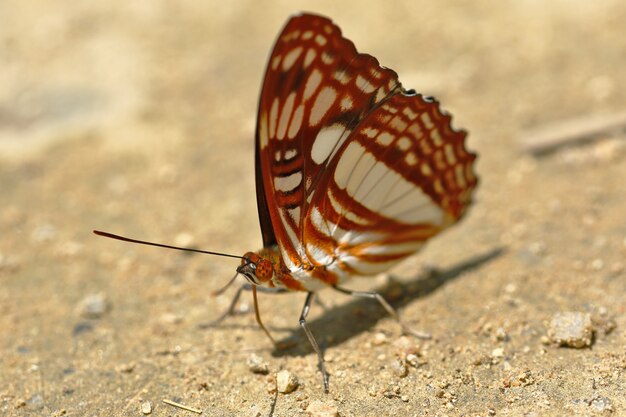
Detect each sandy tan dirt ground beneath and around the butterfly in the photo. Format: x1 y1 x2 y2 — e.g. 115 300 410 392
0 0 626 417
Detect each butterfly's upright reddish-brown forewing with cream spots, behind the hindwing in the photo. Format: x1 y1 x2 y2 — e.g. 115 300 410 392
256 14 401 267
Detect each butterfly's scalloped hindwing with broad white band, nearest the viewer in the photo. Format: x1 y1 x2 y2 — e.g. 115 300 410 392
304 92 477 275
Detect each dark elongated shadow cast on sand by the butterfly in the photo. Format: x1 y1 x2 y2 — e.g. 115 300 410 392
272 247 505 357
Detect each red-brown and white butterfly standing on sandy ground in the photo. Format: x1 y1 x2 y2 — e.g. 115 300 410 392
92 13 477 392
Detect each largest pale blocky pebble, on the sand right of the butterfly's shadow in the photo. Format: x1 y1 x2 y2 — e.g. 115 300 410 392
548 311 593 348
